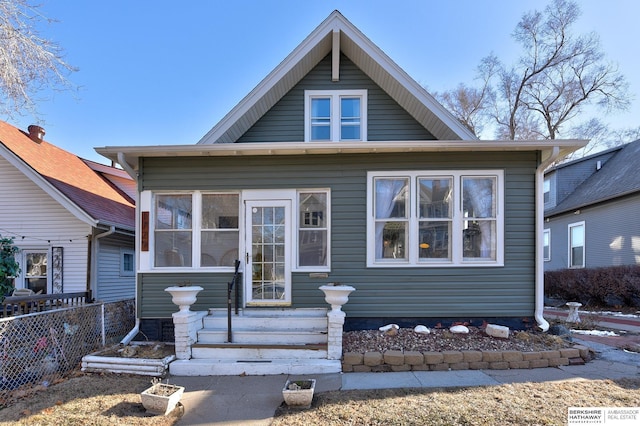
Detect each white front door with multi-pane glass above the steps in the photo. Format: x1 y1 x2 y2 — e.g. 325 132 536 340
243 199 291 306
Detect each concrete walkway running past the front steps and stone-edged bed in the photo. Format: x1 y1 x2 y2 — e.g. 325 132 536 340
169 312 640 426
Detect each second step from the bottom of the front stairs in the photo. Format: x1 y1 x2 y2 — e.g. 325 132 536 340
191 343 327 362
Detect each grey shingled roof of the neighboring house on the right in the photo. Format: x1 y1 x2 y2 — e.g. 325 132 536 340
545 139 640 216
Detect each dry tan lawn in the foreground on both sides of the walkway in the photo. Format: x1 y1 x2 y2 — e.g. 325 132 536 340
0 373 640 426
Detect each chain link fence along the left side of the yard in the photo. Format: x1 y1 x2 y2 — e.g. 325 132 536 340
0 300 135 407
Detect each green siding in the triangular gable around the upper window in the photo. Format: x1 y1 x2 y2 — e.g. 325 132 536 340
237 55 435 143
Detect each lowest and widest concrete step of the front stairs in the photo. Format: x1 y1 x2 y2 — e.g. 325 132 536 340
169 359 342 376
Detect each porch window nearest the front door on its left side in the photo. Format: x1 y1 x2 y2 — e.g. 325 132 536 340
200 194 240 266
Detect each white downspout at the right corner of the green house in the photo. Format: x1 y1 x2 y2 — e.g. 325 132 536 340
535 146 560 332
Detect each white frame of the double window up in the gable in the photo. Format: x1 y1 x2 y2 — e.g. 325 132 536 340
304 89 368 142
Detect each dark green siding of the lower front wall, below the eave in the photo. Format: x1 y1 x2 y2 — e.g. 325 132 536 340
139 152 538 318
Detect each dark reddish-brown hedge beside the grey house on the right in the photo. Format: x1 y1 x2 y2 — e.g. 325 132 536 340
544 265 640 308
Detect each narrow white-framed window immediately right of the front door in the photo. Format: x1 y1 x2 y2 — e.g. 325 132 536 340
298 191 329 270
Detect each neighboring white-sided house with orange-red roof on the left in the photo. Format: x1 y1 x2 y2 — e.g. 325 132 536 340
0 121 136 302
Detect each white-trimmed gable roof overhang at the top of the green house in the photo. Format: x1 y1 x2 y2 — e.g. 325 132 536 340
198 10 477 144
